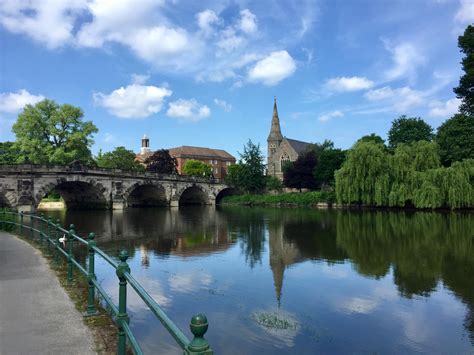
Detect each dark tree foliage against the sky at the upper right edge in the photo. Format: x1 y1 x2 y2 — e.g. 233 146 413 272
454 25 474 116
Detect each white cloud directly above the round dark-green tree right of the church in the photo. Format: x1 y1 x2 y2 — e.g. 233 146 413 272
364 86 426 112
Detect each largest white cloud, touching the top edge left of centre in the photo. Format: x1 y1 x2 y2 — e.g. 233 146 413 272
77 0 198 69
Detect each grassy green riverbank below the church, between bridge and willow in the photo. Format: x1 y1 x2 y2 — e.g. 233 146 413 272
221 191 336 206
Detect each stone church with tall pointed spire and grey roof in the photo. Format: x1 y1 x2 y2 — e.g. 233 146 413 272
267 98 310 180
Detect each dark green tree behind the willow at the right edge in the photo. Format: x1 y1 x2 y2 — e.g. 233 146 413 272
436 114 474 166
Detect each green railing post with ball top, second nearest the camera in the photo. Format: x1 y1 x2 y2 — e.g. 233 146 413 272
116 250 130 355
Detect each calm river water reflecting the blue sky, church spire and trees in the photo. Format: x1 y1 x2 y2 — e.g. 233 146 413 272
41 207 474 354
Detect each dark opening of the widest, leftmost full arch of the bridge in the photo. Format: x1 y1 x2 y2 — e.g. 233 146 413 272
34 178 109 209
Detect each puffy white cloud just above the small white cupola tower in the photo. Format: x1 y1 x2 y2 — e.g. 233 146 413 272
94 84 172 118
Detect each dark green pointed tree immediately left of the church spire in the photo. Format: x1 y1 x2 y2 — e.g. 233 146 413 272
225 139 266 193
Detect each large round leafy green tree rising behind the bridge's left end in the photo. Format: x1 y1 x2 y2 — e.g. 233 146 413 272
12 100 98 165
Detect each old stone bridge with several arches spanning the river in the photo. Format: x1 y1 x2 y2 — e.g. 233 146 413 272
0 165 236 211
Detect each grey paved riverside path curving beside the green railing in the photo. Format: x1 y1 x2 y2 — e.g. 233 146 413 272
0 232 96 355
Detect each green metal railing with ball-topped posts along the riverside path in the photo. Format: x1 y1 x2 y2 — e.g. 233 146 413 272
0 210 213 355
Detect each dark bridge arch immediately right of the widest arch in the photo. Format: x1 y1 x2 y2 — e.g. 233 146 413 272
123 182 169 207
